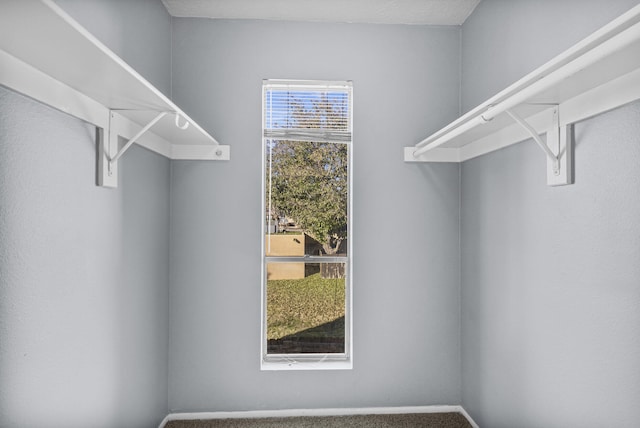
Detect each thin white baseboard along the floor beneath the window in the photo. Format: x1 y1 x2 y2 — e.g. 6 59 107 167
159 406 479 428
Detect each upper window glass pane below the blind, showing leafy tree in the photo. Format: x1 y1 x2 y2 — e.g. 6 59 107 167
265 140 349 256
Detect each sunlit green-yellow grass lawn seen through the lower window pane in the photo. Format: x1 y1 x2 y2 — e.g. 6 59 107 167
267 273 345 340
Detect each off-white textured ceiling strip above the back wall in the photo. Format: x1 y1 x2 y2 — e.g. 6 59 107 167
162 0 480 25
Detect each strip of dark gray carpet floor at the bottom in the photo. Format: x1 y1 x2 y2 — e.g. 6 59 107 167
165 413 472 428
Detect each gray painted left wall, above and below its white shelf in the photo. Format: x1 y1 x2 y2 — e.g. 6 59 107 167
0 0 171 427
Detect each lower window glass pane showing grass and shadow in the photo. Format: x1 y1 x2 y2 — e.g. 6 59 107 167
266 262 346 354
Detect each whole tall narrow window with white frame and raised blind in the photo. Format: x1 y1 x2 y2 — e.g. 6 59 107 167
261 80 352 370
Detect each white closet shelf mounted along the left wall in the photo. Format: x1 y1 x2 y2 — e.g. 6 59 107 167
0 0 228 155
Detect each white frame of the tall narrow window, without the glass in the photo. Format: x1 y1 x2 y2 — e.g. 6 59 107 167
260 79 353 371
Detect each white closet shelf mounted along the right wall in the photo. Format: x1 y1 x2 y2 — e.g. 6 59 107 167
404 6 640 162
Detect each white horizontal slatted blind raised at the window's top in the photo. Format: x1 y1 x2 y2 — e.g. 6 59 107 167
263 81 352 143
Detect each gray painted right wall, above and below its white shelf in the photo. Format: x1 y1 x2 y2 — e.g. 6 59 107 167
461 0 640 427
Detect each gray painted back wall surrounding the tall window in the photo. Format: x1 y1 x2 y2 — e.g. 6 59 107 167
169 19 460 411
